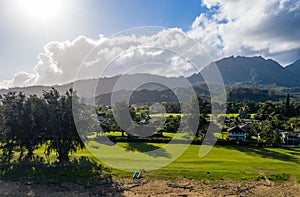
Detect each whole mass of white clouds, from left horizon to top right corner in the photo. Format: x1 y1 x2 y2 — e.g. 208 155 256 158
0 0 300 87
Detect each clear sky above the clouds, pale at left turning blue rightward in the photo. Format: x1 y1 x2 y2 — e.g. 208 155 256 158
0 0 202 80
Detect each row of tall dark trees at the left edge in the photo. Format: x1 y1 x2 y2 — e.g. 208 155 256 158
0 88 84 163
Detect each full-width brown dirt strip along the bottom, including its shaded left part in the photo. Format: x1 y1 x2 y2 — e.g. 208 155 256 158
0 179 300 197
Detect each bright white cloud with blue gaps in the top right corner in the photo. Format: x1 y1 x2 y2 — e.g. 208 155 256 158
188 0 300 65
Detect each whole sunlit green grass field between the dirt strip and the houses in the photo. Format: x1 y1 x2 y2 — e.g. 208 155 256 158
3 129 300 182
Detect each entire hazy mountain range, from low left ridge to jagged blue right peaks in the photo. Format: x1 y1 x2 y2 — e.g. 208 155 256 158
0 56 300 100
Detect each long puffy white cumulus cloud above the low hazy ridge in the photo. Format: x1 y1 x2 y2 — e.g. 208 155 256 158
11 28 211 86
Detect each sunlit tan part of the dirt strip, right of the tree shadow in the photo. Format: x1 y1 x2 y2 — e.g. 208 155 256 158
118 180 300 197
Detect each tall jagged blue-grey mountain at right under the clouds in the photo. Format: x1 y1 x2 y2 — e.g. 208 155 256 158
197 56 300 87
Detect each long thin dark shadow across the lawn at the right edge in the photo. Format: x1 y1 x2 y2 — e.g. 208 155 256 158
221 146 300 164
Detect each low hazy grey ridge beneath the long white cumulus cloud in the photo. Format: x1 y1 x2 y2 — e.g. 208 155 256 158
0 74 186 97
